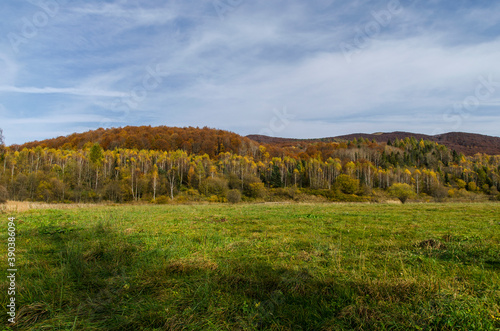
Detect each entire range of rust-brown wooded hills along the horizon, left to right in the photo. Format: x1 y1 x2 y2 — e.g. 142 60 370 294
7 126 500 157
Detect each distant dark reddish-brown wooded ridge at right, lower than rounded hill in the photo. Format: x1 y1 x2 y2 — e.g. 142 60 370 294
247 132 500 155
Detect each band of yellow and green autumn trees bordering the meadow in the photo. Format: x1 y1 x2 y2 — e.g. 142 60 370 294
0 128 500 202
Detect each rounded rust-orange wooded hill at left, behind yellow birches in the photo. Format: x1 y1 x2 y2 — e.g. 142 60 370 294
11 126 258 157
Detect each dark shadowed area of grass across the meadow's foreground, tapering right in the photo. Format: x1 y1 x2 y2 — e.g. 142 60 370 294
8 223 500 330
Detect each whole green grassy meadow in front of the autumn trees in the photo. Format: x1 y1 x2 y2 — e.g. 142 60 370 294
0 203 500 330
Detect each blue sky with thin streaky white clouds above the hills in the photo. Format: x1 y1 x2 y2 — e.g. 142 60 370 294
0 0 500 145
